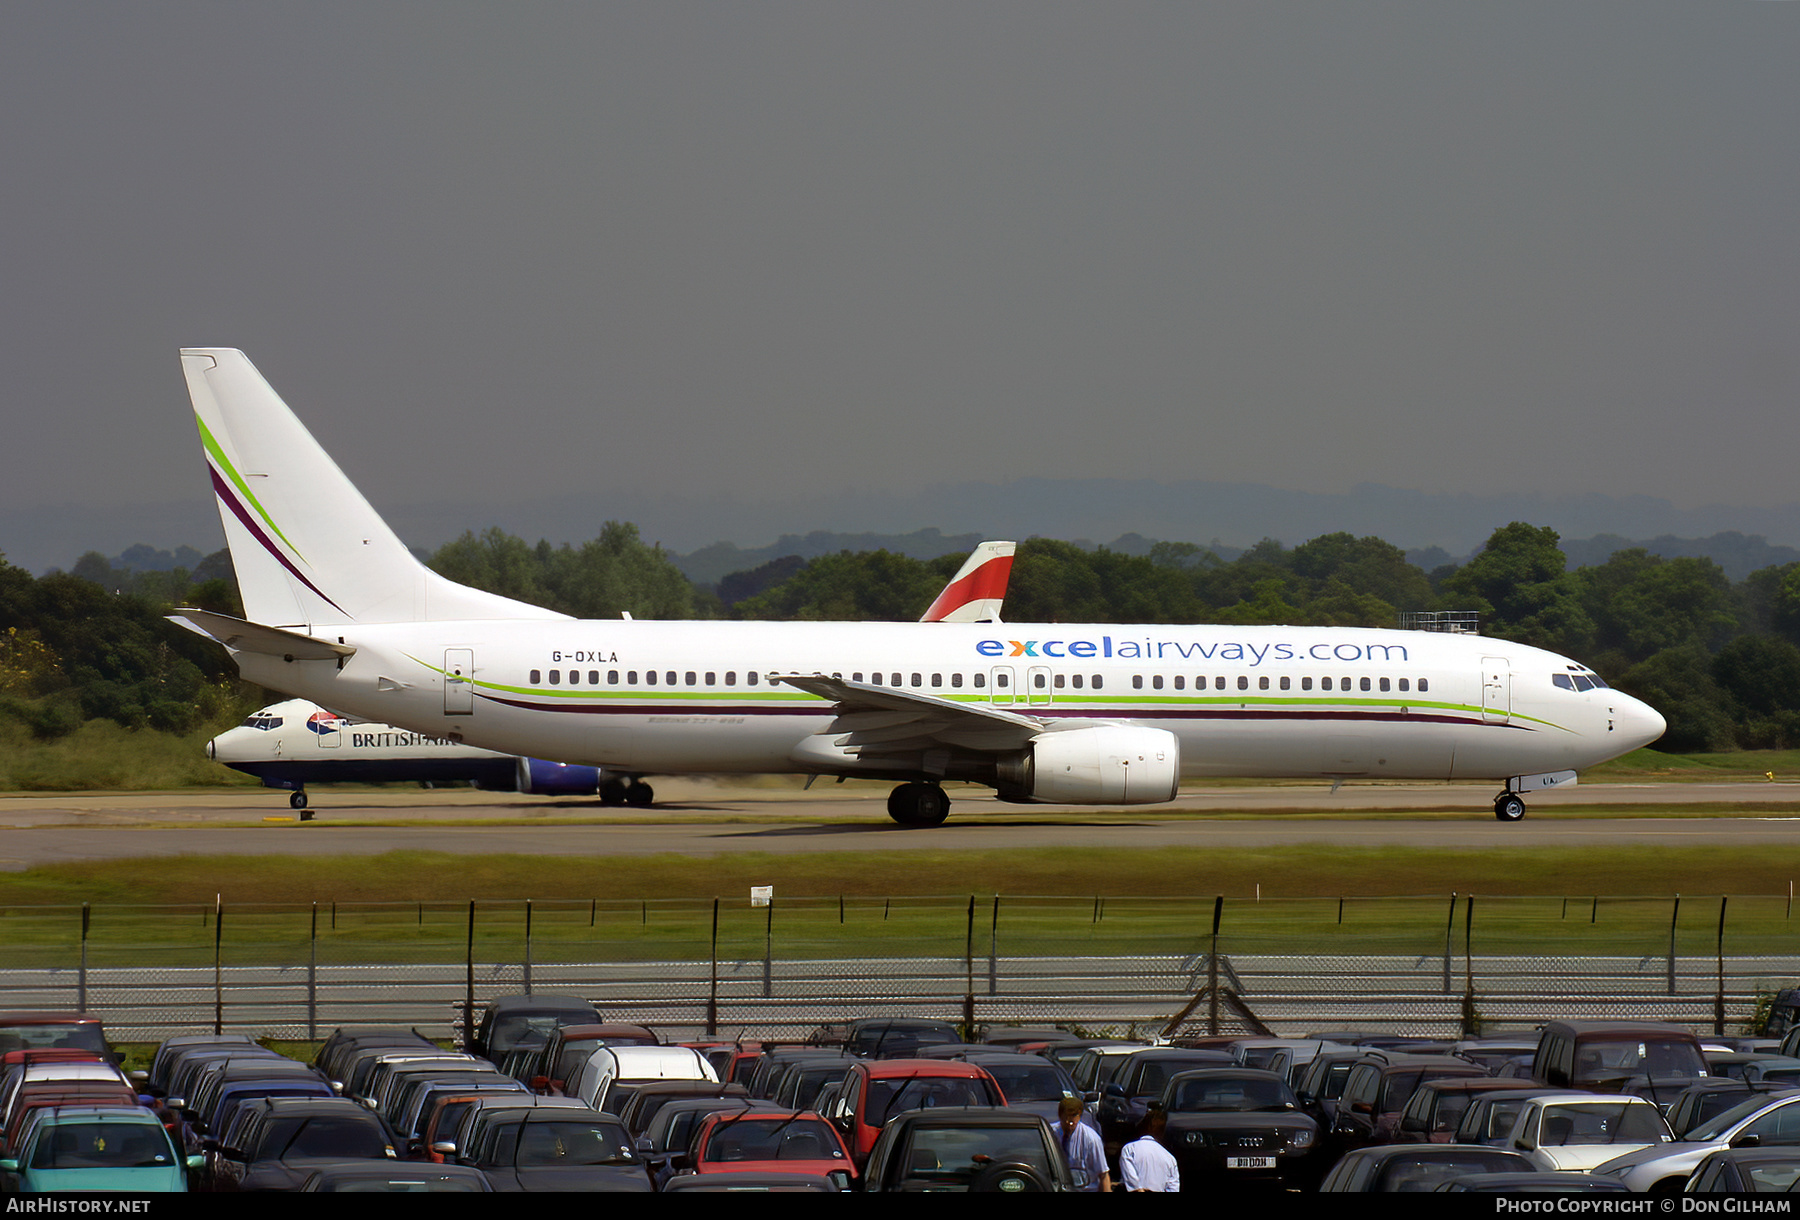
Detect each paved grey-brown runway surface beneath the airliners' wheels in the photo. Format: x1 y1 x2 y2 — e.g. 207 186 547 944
0 779 1800 871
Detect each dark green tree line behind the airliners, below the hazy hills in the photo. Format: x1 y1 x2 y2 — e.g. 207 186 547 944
0 522 1800 752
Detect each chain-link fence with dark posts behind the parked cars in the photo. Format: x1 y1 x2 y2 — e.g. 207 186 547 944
0 896 1800 1042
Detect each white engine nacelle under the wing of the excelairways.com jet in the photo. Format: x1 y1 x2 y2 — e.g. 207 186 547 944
997 725 1181 804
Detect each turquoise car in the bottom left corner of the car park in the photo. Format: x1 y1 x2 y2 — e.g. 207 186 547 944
0 1105 203 1195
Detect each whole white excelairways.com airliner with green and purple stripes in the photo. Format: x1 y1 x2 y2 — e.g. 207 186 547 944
175 347 1663 826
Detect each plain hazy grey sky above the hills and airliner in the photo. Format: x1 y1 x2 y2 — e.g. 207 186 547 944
0 0 1800 551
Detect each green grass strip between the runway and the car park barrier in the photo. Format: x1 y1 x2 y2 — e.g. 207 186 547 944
0 846 1800 966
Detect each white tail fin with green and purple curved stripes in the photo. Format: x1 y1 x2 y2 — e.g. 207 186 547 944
182 347 565 632
